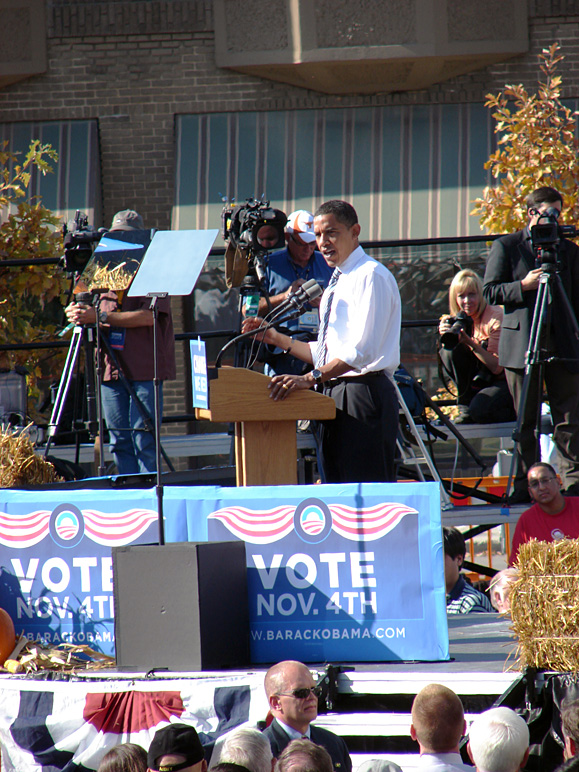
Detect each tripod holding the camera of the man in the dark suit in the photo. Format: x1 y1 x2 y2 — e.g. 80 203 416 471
505 256 579 498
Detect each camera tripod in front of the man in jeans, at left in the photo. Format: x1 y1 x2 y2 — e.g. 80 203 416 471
44 309 175 477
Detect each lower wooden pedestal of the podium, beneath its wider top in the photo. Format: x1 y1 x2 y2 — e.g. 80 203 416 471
235 421 298 485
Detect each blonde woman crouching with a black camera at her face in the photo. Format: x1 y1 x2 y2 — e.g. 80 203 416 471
438 269 516 423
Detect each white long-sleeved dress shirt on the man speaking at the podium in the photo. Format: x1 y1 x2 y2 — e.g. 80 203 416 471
309 247 401 377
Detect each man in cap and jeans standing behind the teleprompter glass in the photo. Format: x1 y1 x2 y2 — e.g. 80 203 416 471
66 209 176 474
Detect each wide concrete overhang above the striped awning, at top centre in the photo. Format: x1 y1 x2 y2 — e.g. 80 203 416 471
214 0 529 94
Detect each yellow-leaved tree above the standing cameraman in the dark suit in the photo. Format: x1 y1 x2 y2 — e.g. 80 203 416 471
471 43 579 233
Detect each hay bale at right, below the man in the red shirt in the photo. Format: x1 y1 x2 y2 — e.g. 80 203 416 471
511 539 579 672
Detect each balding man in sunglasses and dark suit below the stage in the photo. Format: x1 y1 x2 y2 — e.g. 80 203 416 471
264 660 352 772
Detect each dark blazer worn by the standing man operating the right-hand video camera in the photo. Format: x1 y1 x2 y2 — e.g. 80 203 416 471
484 229 579 372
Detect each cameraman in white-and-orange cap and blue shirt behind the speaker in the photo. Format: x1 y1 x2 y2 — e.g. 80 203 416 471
258 209 332 375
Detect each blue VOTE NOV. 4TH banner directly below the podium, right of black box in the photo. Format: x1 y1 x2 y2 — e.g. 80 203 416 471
197 483 449 664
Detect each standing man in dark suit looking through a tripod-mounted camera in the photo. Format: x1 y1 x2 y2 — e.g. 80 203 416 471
484 187 579 503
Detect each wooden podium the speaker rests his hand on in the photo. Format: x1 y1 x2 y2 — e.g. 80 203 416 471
195 367 336 485
